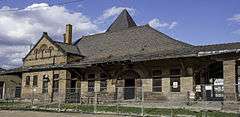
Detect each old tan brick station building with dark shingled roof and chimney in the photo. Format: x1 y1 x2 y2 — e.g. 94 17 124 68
2 10 240 101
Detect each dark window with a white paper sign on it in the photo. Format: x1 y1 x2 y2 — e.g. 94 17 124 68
170 69 181 92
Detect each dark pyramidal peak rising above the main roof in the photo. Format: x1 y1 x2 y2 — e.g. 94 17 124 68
106 9 137 32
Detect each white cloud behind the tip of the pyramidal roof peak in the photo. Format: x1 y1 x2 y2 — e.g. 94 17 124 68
97 6 136 23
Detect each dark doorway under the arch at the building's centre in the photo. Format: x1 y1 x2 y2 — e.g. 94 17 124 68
124 79 135 100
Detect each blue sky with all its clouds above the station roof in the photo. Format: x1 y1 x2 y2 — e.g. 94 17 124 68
0 0 240 67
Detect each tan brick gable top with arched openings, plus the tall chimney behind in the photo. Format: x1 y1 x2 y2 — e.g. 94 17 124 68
23 24 82 66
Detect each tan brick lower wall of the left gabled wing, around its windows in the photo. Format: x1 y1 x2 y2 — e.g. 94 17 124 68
22 70 71 100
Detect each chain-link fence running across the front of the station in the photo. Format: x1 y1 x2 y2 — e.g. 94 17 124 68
0 85 240 117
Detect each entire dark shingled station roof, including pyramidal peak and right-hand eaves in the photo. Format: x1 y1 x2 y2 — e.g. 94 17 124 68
21 10 240 67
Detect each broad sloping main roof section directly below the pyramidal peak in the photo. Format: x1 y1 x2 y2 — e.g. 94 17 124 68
76 25 192 62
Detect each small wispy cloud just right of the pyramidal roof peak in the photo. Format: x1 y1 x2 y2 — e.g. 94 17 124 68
149 18 178 29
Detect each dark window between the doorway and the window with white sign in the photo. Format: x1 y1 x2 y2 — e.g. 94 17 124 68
152 70 162 92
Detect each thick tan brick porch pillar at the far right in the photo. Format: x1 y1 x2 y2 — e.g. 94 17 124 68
223 60 237 101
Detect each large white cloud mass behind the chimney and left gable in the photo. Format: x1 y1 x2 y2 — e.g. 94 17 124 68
0 3 99 68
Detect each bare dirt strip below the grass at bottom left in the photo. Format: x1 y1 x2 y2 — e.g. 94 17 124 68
0 110 127 117
